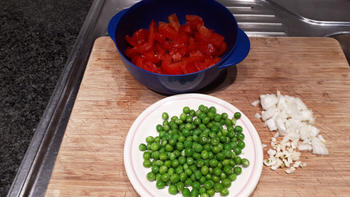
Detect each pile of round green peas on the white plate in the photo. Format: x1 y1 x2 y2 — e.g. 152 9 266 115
139 105 249 197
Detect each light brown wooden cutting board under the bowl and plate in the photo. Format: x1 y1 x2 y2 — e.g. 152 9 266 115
46 37 350 196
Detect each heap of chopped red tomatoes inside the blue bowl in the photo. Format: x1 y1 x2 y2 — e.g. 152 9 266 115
125 14 227 75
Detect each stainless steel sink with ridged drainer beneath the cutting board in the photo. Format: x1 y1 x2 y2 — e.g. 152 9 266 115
8 0 350 197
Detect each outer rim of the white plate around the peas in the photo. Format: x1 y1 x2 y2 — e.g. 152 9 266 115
124 93 263 196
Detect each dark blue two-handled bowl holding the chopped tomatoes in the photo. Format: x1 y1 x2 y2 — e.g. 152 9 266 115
108 0 250 95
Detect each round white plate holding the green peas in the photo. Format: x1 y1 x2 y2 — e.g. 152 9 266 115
124 94 263 197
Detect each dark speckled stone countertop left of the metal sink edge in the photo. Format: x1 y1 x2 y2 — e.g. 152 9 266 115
0 0 92 196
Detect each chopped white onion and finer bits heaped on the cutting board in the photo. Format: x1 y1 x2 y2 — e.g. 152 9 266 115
252 91 328 174
